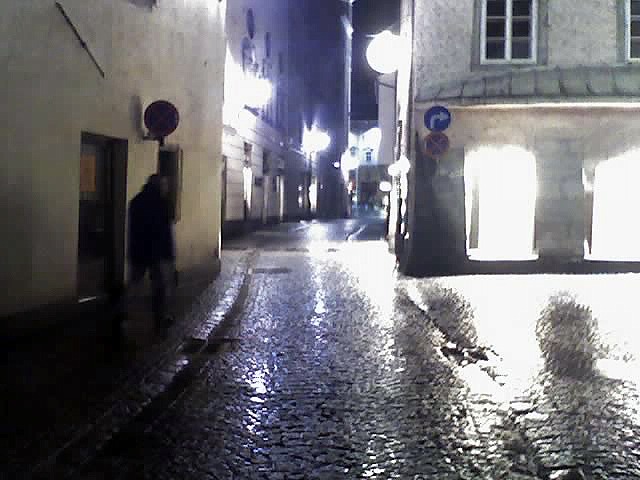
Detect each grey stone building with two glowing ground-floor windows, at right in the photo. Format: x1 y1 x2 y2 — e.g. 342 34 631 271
396 0 640 274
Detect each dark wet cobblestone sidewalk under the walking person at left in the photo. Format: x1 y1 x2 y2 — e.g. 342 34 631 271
0 252 249 478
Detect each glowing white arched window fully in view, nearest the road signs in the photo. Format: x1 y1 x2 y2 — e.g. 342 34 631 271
464 146 537 260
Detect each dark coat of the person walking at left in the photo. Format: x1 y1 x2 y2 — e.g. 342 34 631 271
129 184 175 266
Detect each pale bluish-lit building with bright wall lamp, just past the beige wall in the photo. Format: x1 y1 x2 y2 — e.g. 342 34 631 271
222 0 309 235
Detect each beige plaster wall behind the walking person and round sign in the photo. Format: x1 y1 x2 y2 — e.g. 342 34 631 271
0 0 226 315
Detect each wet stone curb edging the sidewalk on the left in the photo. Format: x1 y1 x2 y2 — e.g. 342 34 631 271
31 251 256 478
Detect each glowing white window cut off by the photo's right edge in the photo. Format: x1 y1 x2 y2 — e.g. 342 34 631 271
590 149 640 260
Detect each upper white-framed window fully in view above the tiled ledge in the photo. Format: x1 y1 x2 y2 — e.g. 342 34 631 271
480 0 536 63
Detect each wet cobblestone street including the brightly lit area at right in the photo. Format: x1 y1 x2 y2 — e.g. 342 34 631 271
71 217 640 480
